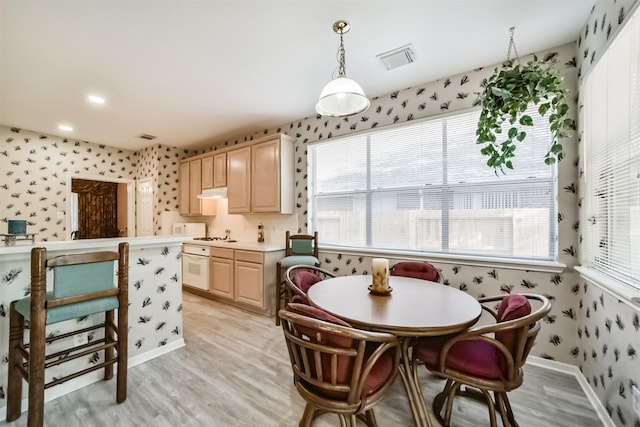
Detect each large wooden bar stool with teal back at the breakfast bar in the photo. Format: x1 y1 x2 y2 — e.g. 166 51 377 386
6 242 129 427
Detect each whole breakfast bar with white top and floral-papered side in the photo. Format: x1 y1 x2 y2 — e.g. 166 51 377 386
0 236 191 419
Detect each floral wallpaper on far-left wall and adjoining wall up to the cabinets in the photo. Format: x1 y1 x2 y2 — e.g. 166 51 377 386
0 126 195 241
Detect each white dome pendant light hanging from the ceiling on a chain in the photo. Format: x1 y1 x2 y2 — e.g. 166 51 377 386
316 21 370 117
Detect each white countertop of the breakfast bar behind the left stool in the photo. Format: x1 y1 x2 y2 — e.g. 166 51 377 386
0 236 193 255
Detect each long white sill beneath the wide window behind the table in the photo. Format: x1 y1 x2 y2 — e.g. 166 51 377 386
320 246 566 273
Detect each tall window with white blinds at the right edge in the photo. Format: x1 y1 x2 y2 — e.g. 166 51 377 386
580 7 640 289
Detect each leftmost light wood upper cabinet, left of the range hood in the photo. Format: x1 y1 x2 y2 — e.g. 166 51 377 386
178 159 217 215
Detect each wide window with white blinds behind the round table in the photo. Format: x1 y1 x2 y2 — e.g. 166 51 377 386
308 108 557 261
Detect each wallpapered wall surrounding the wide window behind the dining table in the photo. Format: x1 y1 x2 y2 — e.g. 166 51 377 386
204 44 578 364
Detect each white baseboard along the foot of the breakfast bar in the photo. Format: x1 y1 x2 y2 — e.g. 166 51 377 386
0 338 185 420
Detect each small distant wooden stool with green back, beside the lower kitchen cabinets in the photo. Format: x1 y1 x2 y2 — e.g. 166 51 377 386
276 231 320 326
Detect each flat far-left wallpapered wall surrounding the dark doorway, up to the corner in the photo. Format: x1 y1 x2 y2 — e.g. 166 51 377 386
0 126 138 241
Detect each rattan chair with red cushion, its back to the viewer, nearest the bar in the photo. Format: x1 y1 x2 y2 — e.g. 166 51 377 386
278 303 400 427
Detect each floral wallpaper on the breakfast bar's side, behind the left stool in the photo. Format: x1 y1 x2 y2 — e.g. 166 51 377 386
0 243 182 409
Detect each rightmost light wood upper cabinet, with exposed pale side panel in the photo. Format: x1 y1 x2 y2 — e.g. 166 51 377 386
251 135 294 214
